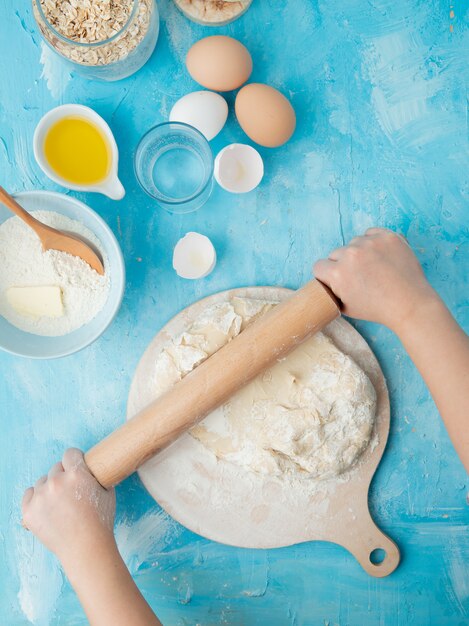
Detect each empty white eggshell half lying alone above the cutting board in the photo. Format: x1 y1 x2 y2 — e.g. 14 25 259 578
173 232 217 280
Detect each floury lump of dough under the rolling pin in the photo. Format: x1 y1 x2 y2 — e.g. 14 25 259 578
154 298 376 479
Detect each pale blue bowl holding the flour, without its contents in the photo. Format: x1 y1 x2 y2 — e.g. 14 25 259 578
0 191 125 359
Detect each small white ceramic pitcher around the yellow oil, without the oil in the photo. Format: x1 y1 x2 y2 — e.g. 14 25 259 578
33 104 125 200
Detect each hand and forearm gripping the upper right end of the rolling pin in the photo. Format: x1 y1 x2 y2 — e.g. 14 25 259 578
314 228 469 471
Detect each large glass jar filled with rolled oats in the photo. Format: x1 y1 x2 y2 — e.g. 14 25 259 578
32 0 159 81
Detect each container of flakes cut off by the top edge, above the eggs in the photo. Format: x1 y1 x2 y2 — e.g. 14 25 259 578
174 0 252 26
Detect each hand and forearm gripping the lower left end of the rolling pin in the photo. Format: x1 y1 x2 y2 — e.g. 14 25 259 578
22 448 161 626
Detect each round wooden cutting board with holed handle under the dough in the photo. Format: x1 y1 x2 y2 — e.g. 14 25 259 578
127 287 399 577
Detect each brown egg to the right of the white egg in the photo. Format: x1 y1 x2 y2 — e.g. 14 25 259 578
235 83 296 148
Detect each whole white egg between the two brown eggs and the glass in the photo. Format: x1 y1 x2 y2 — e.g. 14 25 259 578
169 91 228 141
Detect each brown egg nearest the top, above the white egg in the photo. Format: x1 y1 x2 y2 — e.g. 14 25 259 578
186 35 252 91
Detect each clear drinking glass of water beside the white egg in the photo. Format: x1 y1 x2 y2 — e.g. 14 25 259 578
135 122 213 213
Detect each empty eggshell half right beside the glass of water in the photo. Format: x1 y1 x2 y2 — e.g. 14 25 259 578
214 143 264 193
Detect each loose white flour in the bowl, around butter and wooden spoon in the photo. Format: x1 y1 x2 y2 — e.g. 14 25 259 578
0 211 110 336
